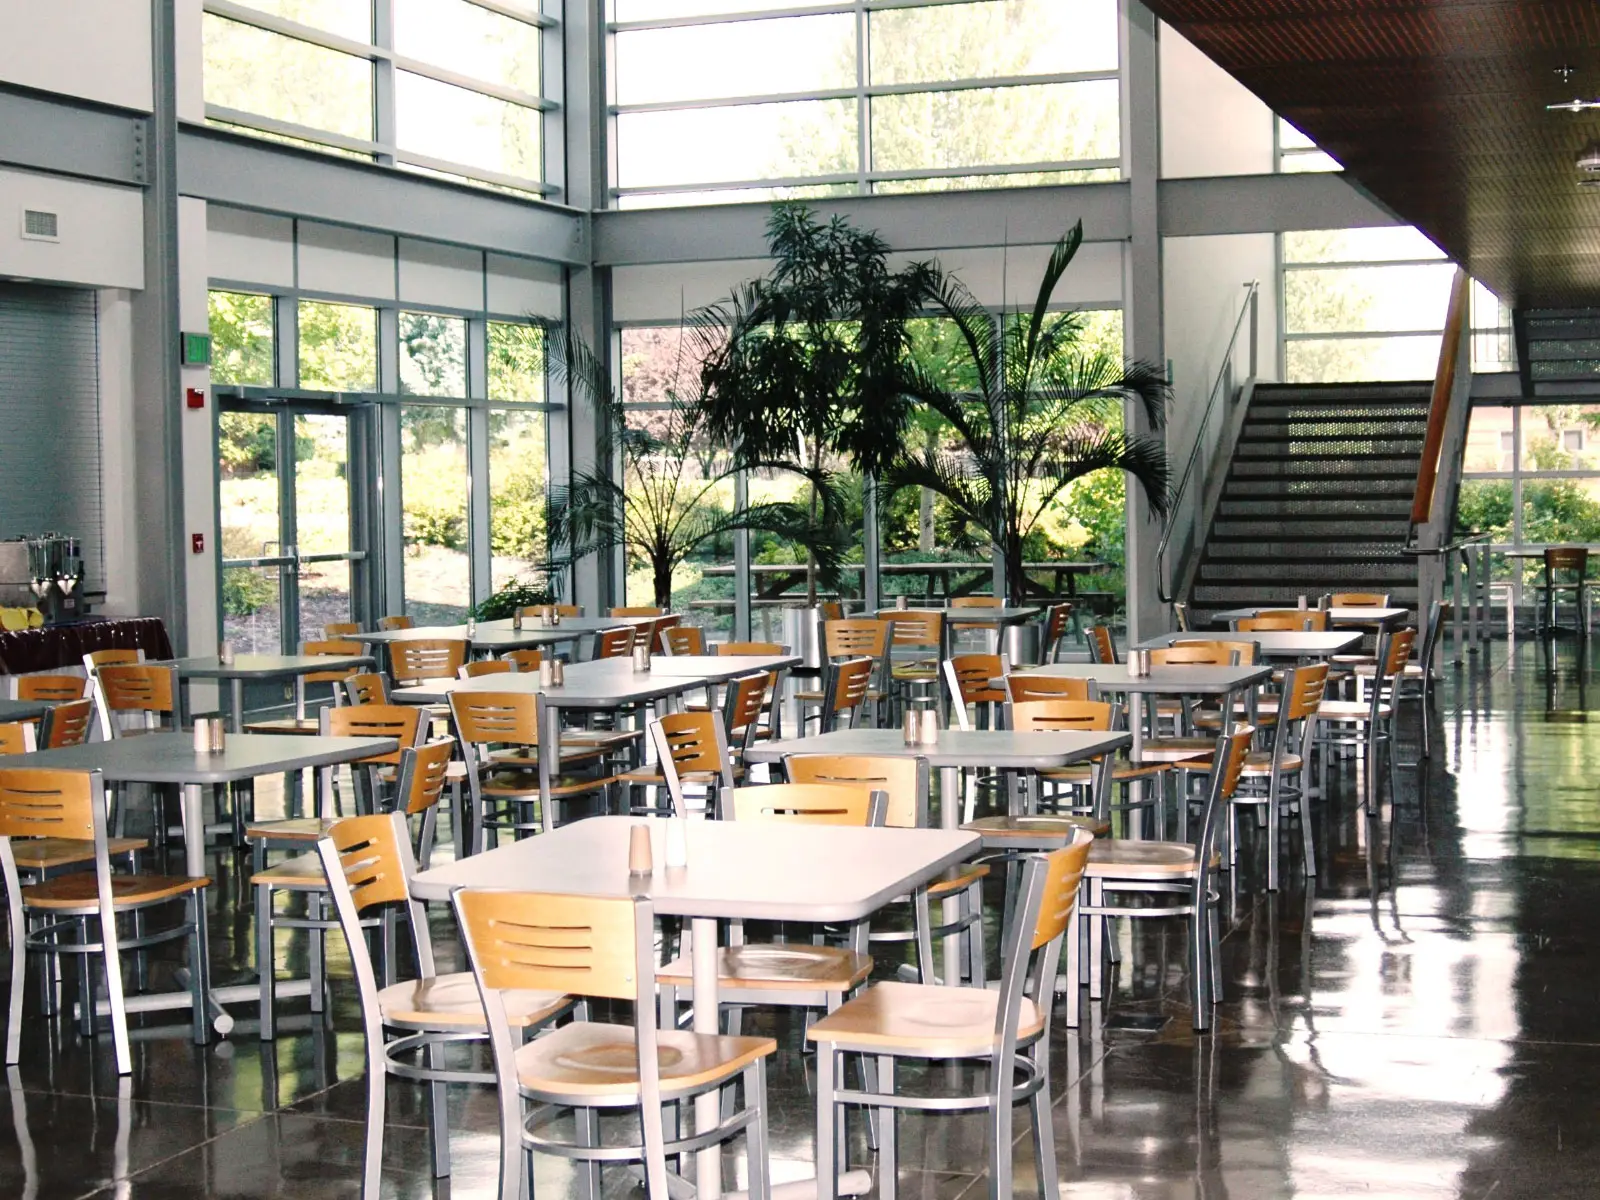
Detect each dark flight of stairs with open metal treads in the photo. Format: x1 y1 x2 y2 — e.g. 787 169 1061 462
1190 382 1430 626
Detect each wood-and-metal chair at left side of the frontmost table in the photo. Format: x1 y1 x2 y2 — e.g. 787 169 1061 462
310 813 576 1200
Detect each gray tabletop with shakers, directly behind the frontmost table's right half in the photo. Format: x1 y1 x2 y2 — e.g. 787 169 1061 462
744 730 1130 771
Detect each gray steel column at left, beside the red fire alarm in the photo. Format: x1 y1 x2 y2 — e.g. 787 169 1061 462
130 0 189 654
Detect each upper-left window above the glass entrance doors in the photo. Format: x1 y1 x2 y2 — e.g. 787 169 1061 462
203 0 557 194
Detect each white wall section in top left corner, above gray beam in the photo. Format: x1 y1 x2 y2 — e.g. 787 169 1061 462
0 0 151 112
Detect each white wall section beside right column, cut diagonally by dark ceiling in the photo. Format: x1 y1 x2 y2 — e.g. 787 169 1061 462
1160 24 1274 179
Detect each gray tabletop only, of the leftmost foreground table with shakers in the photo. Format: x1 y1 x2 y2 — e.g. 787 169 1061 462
16 733 397 784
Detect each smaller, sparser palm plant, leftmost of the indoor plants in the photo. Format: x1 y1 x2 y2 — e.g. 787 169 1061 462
547 333 840 608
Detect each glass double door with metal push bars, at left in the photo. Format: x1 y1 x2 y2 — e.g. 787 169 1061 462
218 402 366 654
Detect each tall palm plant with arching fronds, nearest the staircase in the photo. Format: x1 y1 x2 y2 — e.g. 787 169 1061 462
882 221 1168 603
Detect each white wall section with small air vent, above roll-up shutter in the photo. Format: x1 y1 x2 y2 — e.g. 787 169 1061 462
0 170 144 288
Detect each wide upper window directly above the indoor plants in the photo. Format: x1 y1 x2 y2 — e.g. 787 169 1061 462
613 0 1120 205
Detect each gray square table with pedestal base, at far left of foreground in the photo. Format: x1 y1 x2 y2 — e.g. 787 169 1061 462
18 733 397 1043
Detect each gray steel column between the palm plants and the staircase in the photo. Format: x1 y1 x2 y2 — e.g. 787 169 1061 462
1120 0 1171 643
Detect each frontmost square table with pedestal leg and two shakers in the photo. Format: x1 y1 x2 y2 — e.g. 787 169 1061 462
411 819 979 1198
